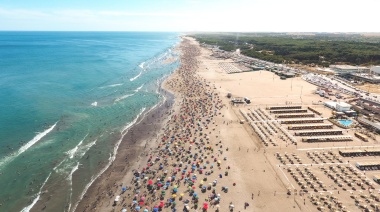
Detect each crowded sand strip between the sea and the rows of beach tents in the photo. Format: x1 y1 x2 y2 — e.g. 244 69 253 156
72 38 308 211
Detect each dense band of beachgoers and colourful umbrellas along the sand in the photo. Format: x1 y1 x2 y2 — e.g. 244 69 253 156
107 39 235 212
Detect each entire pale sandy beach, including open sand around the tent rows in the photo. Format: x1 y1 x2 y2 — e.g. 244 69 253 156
76 37 378 211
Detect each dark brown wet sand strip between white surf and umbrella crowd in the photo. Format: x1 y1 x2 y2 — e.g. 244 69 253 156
72 89 174 211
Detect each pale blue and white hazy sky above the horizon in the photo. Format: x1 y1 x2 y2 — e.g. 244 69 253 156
0 0 380 32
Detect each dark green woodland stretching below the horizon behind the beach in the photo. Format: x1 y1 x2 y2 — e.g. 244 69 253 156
192 33 380 67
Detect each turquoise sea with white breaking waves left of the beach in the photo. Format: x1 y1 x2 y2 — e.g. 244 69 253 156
0 32 179 211
